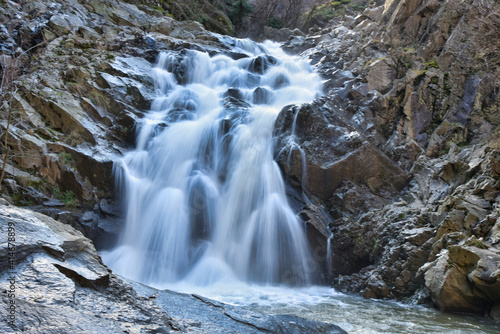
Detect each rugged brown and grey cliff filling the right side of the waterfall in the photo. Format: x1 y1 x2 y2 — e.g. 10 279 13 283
275 0 500 318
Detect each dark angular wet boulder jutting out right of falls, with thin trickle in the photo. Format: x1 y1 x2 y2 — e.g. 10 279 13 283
275 98 408 200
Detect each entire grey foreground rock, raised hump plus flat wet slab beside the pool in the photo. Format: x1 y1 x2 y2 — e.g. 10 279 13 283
0 204 345 334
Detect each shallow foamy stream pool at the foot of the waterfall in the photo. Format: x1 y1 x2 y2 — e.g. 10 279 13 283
191 284 500 334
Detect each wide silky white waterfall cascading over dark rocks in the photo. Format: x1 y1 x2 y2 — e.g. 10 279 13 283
102 40 322 287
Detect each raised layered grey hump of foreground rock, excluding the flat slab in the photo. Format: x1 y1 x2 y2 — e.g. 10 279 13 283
0 206 180 333
